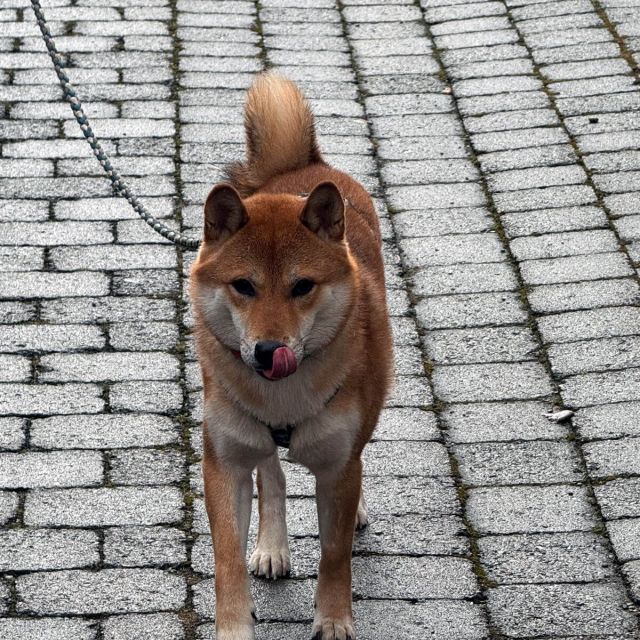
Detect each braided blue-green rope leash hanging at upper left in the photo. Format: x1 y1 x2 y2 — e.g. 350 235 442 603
31 0 200 249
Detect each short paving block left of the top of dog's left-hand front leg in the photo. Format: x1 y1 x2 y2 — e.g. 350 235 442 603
109 450 183 485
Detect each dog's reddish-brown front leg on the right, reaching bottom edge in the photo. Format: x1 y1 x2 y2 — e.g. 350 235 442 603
313 459 362 640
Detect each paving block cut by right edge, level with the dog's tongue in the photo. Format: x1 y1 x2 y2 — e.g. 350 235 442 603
549 336 640 376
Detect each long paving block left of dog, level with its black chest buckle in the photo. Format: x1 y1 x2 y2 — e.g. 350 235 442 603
30 414 179 449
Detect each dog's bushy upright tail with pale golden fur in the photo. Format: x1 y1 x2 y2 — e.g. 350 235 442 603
227 72 322 196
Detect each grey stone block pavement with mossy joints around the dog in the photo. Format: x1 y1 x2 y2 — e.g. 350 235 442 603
0 0 640 640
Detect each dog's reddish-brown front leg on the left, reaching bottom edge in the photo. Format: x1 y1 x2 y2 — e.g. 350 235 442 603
202 430 255 640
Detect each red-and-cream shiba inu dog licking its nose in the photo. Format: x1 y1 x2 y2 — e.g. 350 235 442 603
191 73 392 640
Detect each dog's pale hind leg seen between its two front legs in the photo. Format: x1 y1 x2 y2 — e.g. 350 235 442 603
249 451 291 580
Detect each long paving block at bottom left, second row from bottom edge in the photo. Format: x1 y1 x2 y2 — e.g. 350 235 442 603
16 569 186 615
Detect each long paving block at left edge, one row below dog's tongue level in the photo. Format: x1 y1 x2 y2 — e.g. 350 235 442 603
0 384 104 416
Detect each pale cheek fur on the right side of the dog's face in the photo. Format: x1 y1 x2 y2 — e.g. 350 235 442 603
301 281 353 354
